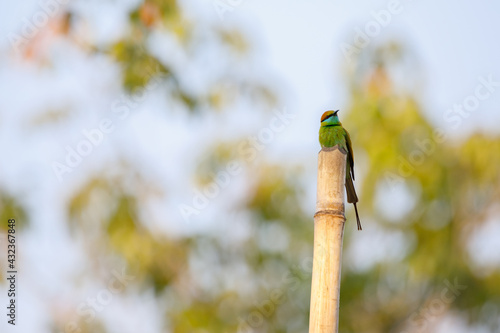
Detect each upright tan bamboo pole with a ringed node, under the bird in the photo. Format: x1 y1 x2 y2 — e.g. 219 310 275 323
309 146 346 333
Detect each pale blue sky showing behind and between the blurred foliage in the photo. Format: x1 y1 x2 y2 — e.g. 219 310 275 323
0 0 500 332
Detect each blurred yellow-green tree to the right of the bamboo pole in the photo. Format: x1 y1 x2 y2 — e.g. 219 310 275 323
340 43 500 332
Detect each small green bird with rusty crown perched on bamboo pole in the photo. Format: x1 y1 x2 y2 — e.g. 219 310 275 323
319 110 362 230
